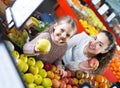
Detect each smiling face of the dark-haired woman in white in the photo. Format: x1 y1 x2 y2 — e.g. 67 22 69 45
87 32 109 55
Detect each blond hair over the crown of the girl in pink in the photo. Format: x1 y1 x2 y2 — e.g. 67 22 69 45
56 16 77 34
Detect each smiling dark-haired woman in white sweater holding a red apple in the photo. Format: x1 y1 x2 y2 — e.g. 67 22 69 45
57 30 116 75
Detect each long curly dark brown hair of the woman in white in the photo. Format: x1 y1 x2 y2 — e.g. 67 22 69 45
94 30 116 74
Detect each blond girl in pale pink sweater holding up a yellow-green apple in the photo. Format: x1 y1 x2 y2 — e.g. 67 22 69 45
23 16 77 63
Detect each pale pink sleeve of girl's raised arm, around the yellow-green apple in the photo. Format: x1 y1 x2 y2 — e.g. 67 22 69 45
23 33 49 55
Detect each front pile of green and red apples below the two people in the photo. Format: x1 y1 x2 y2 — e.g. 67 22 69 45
11 50 112 88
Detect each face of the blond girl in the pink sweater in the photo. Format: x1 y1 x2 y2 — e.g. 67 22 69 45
53 23 74 44
